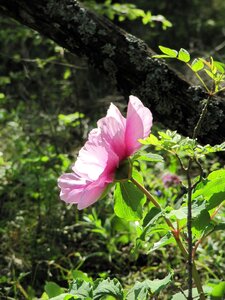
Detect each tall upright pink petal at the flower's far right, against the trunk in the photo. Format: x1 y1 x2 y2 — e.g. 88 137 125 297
125 96 152 156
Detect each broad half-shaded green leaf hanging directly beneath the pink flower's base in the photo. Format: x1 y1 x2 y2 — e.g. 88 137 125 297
114 181 146 221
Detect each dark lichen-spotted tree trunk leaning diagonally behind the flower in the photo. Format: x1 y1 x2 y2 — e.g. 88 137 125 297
0 0 225 144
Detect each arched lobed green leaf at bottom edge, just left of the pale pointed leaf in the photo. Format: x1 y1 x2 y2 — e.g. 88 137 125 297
93 278 124 300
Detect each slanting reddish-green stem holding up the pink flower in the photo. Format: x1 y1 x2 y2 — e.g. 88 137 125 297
130 177 205 300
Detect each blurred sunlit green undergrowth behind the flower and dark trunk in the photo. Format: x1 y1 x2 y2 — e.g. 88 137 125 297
0 0 225 299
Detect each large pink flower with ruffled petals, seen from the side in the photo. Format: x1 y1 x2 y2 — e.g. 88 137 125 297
58 96 152 209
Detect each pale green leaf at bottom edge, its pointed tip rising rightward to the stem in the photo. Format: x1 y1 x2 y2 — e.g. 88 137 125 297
126 274 172 300
